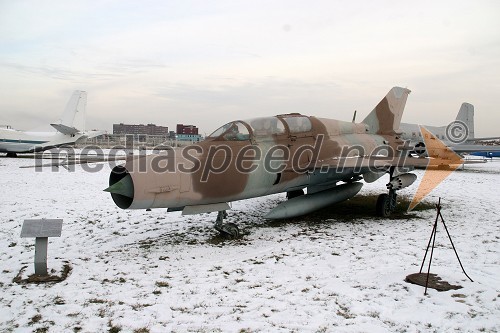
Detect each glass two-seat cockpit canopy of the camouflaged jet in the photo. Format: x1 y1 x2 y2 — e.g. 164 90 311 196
208 114 312 141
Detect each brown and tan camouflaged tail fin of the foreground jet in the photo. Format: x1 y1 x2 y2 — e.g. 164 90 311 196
362 87 411 134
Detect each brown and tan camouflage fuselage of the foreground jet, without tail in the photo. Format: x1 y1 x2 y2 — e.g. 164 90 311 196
110 115 402 209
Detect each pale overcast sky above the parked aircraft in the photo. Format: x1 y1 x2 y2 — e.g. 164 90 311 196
0 0 500 136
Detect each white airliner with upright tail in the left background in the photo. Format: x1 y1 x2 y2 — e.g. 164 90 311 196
0 90 105 157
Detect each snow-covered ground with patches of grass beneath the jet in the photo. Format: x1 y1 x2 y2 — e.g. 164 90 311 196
0 158 500 332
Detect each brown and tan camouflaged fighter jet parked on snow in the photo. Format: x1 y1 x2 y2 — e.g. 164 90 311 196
105 87 434 237
